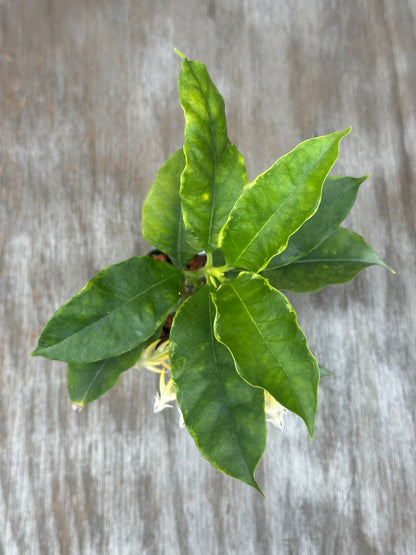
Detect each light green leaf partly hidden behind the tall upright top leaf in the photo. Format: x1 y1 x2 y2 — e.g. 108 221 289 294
142 149 202 269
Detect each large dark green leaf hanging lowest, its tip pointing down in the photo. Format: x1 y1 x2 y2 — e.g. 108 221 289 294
170 287 266 491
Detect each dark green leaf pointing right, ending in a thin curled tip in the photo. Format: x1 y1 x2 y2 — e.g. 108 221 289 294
262 227 393 293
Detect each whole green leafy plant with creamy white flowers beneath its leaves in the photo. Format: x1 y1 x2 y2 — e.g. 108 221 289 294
32 52 388 489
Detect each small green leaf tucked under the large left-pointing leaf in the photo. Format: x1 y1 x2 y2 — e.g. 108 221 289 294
67 343 146 408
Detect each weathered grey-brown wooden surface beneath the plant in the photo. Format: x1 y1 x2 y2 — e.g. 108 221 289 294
0 0 416 555
